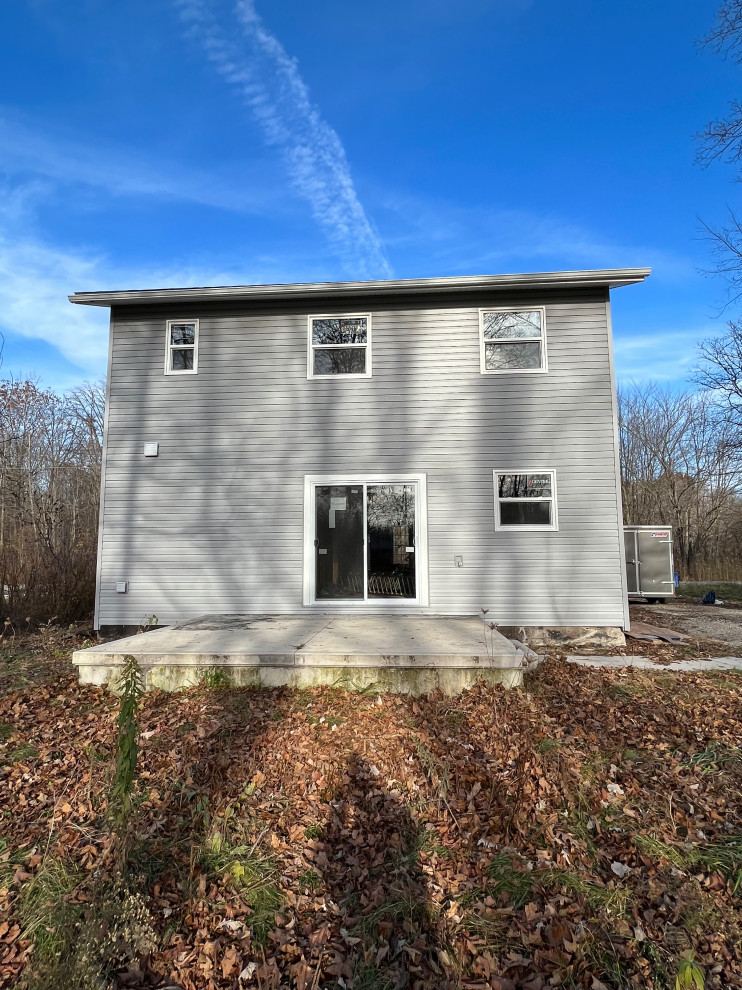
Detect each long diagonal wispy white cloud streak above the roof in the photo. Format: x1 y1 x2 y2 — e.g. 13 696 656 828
175 0 391 278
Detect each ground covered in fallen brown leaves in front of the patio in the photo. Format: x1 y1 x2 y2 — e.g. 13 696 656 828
0 630 742 990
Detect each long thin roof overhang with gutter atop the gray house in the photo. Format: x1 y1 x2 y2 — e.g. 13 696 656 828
69 268 651 306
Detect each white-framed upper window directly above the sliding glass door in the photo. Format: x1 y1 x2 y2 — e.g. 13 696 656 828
307 313 371 378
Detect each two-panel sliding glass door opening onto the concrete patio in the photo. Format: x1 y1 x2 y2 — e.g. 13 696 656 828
311 479 420 603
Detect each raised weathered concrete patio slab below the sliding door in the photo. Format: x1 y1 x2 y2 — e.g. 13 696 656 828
73 614 527 694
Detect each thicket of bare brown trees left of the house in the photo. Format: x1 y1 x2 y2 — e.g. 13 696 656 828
0 380 104 623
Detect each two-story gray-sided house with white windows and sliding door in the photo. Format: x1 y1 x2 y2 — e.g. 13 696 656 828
70 268 649 644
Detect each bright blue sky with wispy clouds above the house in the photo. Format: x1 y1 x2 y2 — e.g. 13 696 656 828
0 0 742 388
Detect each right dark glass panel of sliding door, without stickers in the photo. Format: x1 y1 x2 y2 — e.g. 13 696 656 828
366 485 417 598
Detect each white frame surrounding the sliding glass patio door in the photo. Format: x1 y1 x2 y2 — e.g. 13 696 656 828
303 472 430 612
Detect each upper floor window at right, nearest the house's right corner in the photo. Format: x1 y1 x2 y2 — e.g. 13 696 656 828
479 307 546 375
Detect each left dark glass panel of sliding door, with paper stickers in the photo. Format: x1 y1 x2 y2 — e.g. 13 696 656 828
314 485 363 599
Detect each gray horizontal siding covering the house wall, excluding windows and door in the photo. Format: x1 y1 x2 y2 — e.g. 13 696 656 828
93 290 623 625
